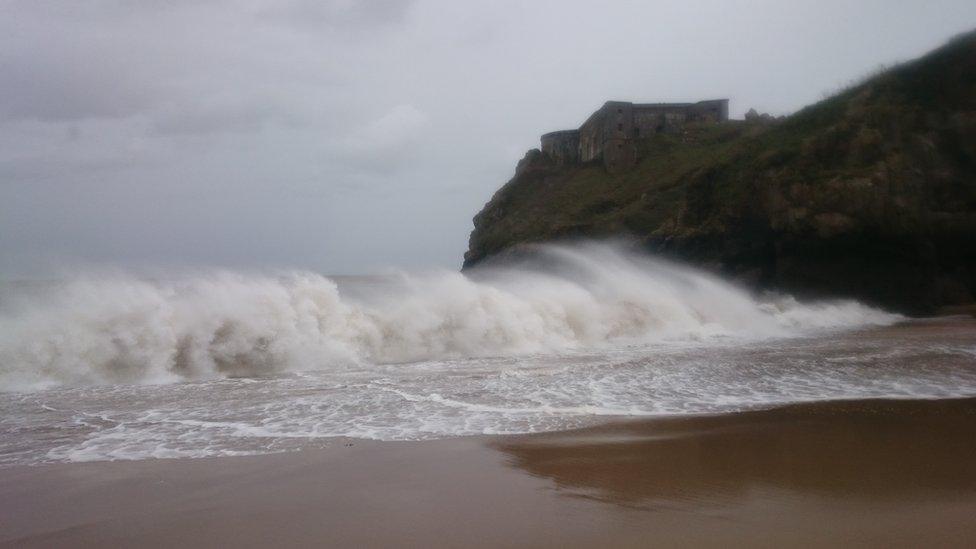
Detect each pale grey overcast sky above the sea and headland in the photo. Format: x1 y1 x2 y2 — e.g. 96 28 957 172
0 0 976 278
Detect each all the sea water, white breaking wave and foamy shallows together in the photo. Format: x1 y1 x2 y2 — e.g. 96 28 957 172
0 244 976 466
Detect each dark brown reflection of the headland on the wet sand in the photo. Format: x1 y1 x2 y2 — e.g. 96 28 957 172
493 399 976 508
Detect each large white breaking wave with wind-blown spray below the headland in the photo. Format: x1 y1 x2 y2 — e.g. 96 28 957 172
0 244 900 391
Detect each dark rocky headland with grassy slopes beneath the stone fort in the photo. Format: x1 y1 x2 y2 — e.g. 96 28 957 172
465 32 976 312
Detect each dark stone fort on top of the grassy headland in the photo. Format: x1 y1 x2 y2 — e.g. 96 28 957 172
542 99 729 171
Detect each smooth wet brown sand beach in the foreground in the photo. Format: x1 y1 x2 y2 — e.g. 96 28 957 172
0 399 976 547
